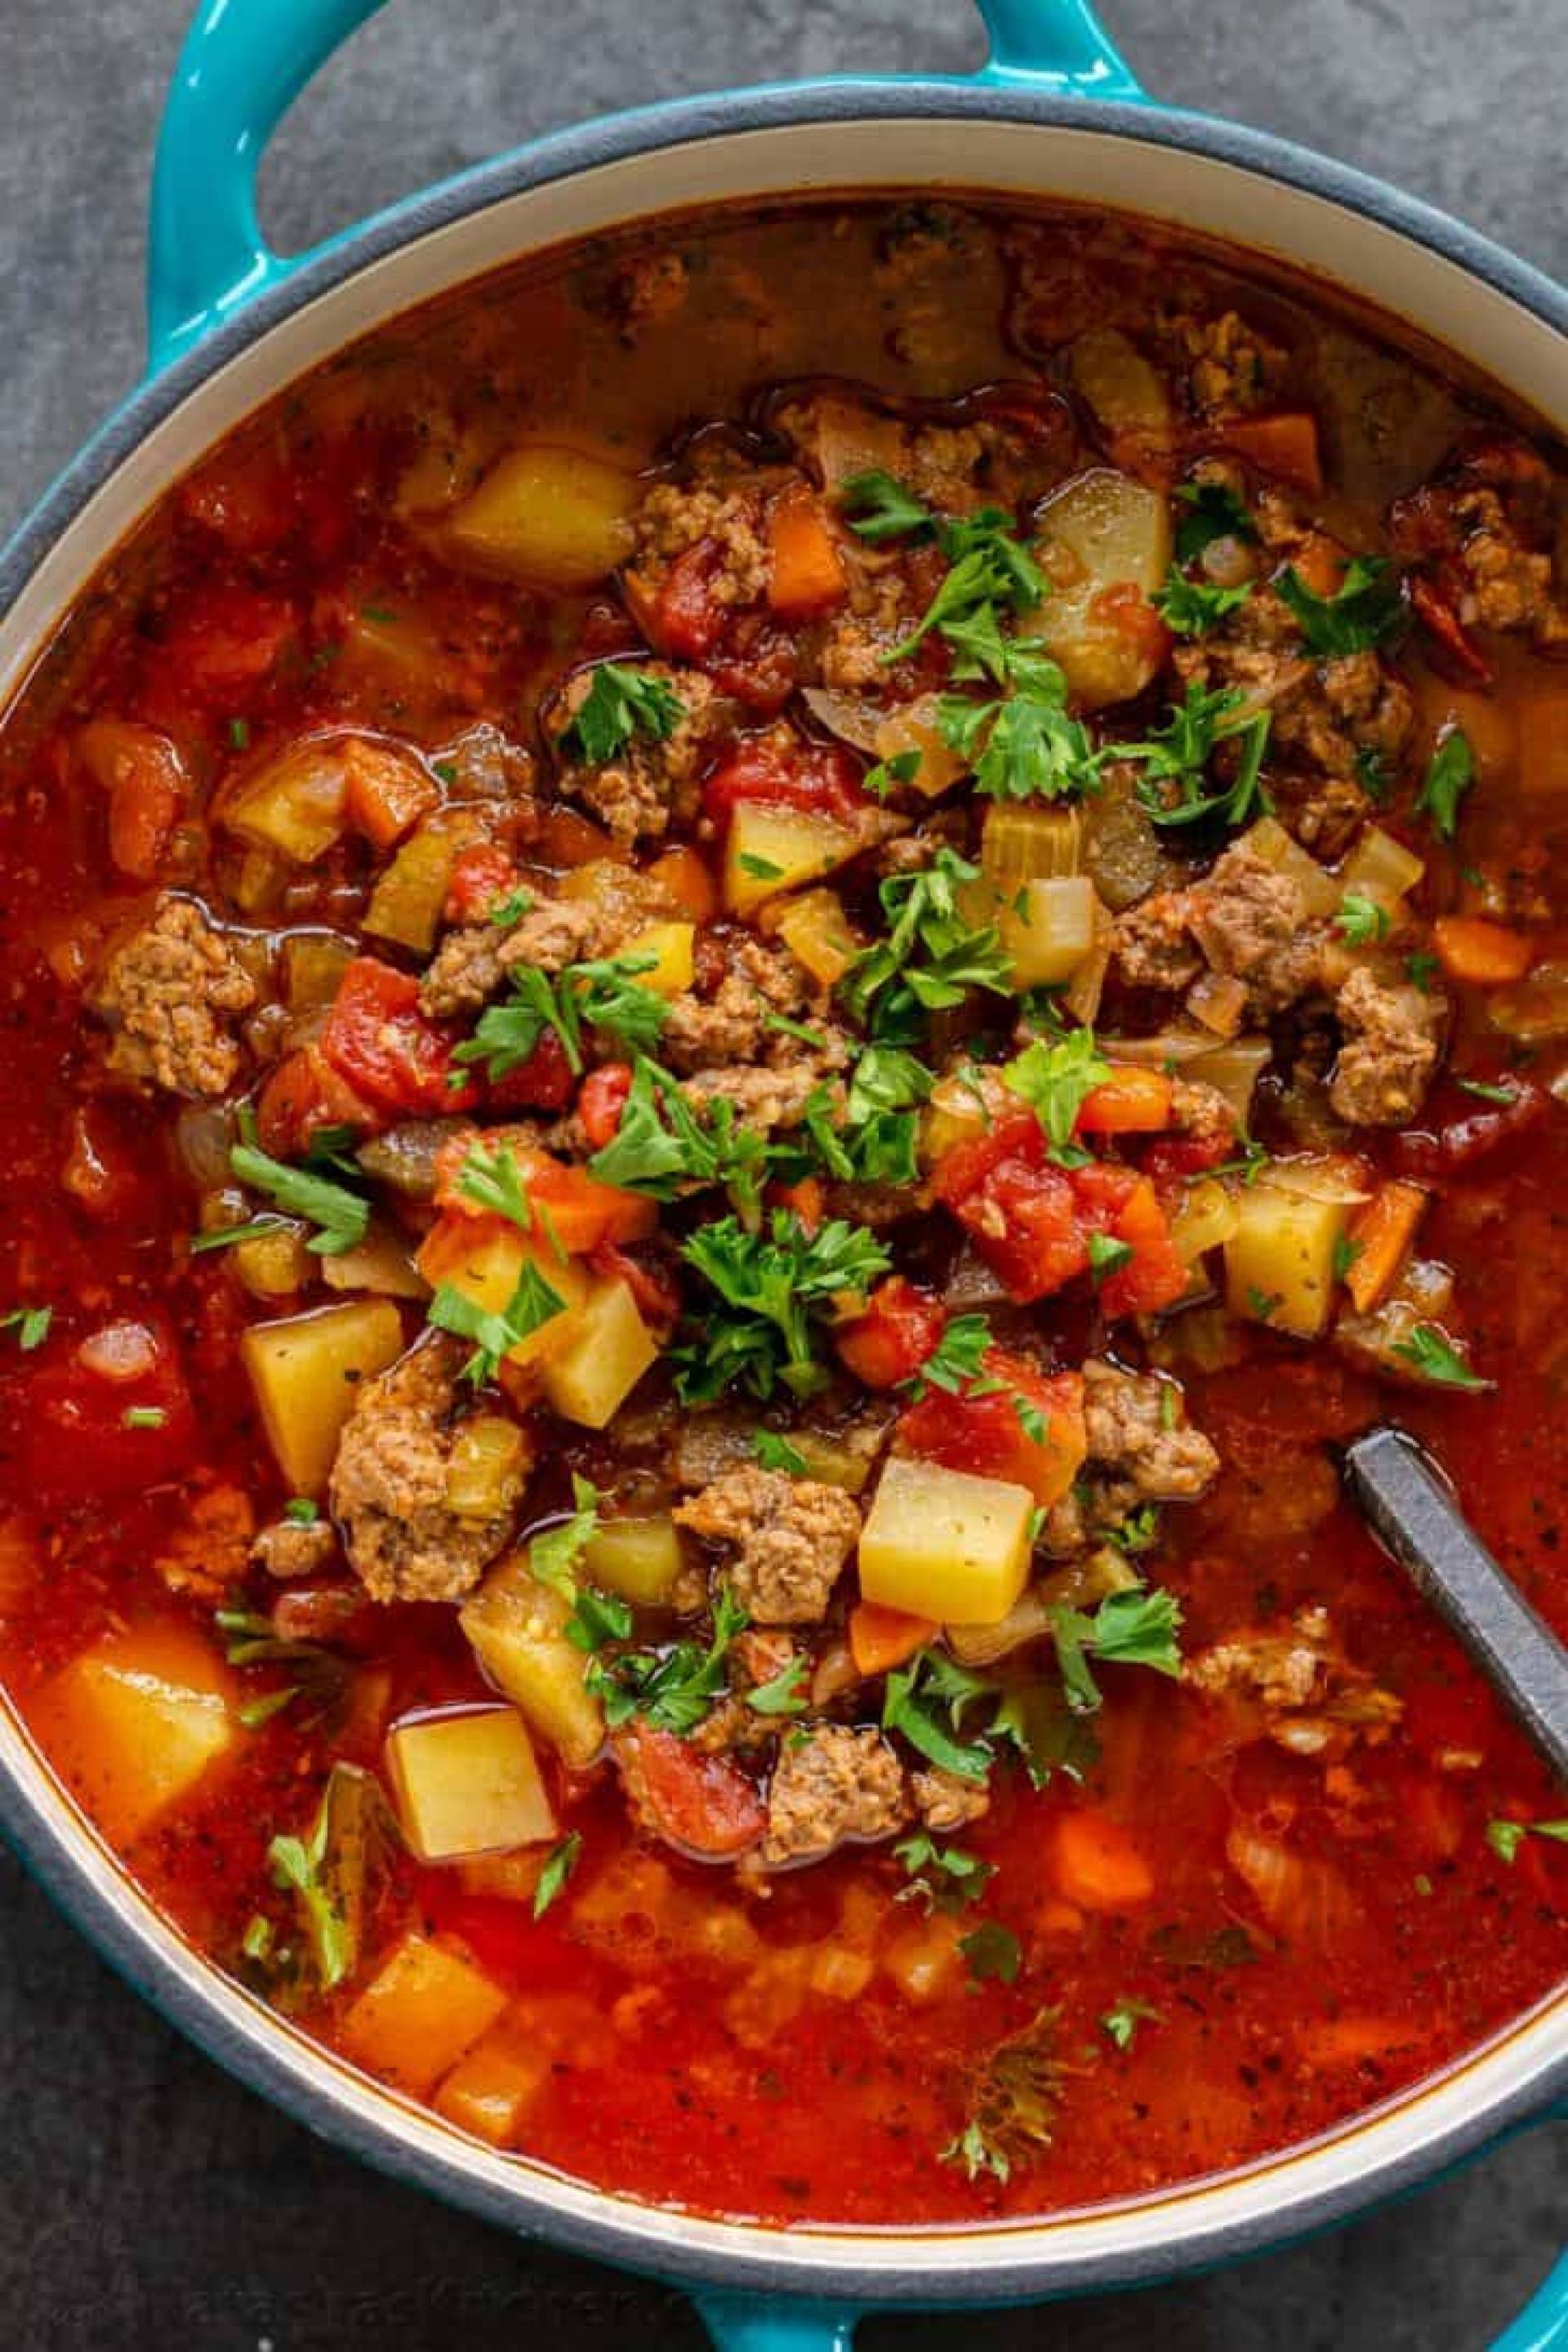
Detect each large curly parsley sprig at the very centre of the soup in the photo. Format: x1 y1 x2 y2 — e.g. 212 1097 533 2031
672 1209 891 1404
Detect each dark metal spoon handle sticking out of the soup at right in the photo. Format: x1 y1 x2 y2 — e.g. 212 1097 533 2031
1345 1430 1568 1780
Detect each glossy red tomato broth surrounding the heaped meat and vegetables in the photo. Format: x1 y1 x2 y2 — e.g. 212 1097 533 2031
0 207 1568 2223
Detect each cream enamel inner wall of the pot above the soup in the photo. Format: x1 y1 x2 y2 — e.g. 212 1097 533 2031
0 118 1568 2296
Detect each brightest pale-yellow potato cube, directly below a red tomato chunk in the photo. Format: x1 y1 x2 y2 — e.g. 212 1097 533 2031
861 1454 1035 1625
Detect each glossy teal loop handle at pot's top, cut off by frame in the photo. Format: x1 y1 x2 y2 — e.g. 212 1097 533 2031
148 0 1143 376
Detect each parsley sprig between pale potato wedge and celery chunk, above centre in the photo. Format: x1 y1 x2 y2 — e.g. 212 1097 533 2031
840 849 1011 1042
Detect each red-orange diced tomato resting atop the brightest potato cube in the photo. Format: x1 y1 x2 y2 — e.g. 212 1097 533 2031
898 1348 1089 1508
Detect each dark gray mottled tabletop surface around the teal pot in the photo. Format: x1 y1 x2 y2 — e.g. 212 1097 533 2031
0 0 1568 2352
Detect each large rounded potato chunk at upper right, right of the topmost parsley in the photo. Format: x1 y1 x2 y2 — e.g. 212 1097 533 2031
1030 466 1171 710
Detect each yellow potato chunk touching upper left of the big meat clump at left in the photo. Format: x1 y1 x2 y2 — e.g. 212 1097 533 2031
240 1298 402 1494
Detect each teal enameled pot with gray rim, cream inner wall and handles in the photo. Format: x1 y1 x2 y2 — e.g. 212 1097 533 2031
0 0 1568 2352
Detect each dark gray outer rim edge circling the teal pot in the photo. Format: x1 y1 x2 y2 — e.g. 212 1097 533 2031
0 78 1568 2310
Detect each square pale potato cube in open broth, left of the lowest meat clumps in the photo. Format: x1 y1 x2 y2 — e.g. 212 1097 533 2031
385 1708 555 1863
